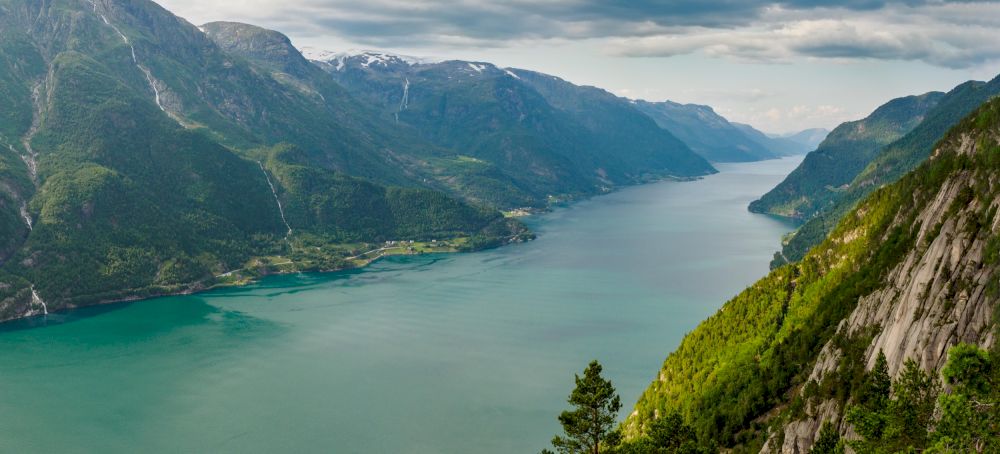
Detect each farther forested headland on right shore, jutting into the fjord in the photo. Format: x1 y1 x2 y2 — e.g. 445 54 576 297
750 92 944 219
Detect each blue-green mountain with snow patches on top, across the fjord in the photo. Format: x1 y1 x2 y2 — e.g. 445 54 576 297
304 52 714 206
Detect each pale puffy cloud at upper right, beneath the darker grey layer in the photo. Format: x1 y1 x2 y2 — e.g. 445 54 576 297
607 2 1000 68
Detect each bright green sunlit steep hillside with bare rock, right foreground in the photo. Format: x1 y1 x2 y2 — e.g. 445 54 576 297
624 97 1000 452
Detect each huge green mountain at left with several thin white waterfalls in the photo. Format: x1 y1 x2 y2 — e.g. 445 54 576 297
0 0 522 320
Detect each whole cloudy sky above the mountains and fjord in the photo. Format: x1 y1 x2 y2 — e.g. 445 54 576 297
160 0 1000 132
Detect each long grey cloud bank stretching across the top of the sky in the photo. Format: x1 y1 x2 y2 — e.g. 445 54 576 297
164 0 1000 68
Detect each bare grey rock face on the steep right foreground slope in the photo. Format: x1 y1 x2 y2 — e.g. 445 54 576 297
762 135 1000 454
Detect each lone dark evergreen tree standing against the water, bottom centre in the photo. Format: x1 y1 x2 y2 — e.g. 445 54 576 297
543 361 622 454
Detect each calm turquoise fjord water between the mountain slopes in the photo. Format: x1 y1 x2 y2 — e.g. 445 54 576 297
0 158 800 453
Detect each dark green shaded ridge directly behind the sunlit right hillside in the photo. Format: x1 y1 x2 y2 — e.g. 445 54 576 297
773 78 1000 266
